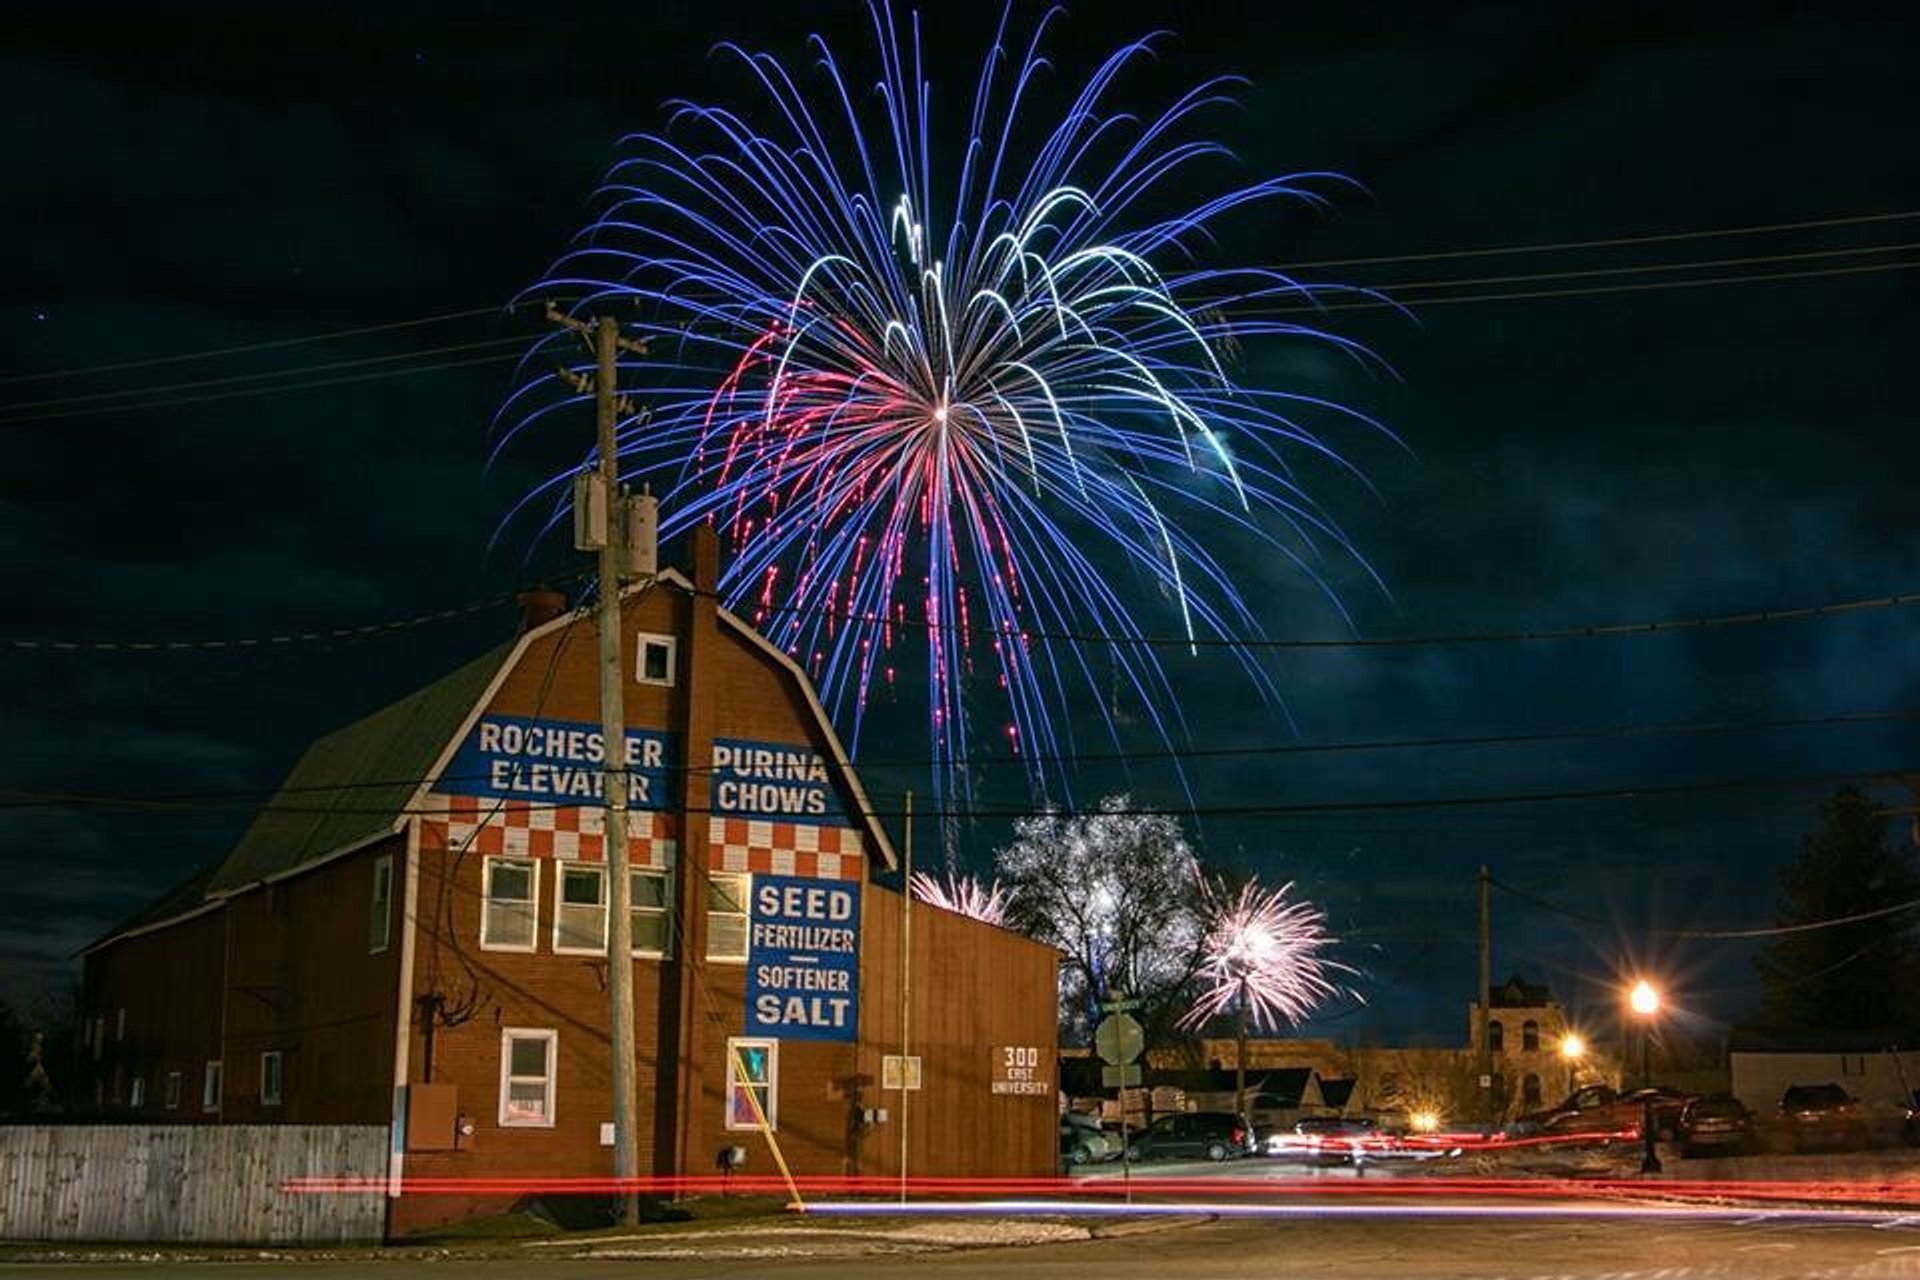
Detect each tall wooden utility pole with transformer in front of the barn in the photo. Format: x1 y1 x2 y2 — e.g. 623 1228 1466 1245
547 303 648 1226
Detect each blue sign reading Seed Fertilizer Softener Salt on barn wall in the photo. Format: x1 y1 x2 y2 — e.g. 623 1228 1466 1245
747 875 860 1040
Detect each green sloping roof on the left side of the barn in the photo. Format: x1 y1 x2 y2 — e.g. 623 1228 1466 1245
207 645 513 894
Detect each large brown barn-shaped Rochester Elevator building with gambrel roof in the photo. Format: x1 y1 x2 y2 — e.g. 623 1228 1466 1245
84 535 1056 1234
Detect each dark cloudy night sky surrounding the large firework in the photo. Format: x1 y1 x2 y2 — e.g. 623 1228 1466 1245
0 4 1920 1040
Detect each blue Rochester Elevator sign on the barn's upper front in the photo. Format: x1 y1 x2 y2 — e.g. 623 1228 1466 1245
434 716 674 810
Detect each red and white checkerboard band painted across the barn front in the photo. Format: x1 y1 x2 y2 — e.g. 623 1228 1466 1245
420 796 864 881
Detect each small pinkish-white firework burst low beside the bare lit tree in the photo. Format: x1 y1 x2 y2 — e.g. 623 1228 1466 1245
1179 881 1354 1029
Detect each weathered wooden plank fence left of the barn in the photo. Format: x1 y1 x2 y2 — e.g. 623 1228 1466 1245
0 1125 388 1244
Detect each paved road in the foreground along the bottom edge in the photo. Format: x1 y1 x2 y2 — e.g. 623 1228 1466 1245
0 1201 1920 1280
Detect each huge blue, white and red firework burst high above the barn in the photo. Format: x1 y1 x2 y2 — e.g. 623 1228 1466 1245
495 4 1377 802
